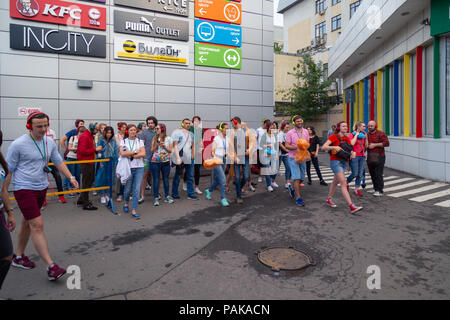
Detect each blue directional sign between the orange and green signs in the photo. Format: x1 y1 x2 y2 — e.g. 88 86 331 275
195 19 242 47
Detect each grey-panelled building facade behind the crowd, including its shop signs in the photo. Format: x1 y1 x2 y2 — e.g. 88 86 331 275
0 0 274 151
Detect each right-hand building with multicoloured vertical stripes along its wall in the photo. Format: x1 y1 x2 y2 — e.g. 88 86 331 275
329 0 450 182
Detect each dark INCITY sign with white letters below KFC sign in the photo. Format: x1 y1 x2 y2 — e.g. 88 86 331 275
9 24 106 58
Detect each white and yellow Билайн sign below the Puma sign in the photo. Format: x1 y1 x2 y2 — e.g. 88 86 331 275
114 36 189 65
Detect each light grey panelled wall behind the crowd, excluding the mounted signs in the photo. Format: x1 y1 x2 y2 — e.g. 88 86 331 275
0 0 274 152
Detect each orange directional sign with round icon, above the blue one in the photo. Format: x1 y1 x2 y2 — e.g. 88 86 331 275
195 0 242 24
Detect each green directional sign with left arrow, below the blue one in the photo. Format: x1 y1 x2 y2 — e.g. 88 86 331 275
195 43 242 69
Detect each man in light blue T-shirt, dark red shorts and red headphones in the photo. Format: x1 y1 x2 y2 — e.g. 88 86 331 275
5 112 78 280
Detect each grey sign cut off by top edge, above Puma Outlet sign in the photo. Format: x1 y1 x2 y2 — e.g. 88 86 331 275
114 0 189 17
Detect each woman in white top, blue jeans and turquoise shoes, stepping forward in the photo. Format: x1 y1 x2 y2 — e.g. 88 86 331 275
205 122 229 207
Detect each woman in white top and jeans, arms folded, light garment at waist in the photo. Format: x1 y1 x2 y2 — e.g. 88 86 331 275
119 124 145 218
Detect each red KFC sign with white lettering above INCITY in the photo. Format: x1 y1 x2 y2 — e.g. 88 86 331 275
9 0 106 30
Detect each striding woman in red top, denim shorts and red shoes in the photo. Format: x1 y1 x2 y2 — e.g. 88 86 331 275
322 121 362 214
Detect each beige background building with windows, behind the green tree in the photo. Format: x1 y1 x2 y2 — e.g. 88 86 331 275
275 0 362 138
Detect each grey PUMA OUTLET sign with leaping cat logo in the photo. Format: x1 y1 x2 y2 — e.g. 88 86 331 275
114 10 189 41
